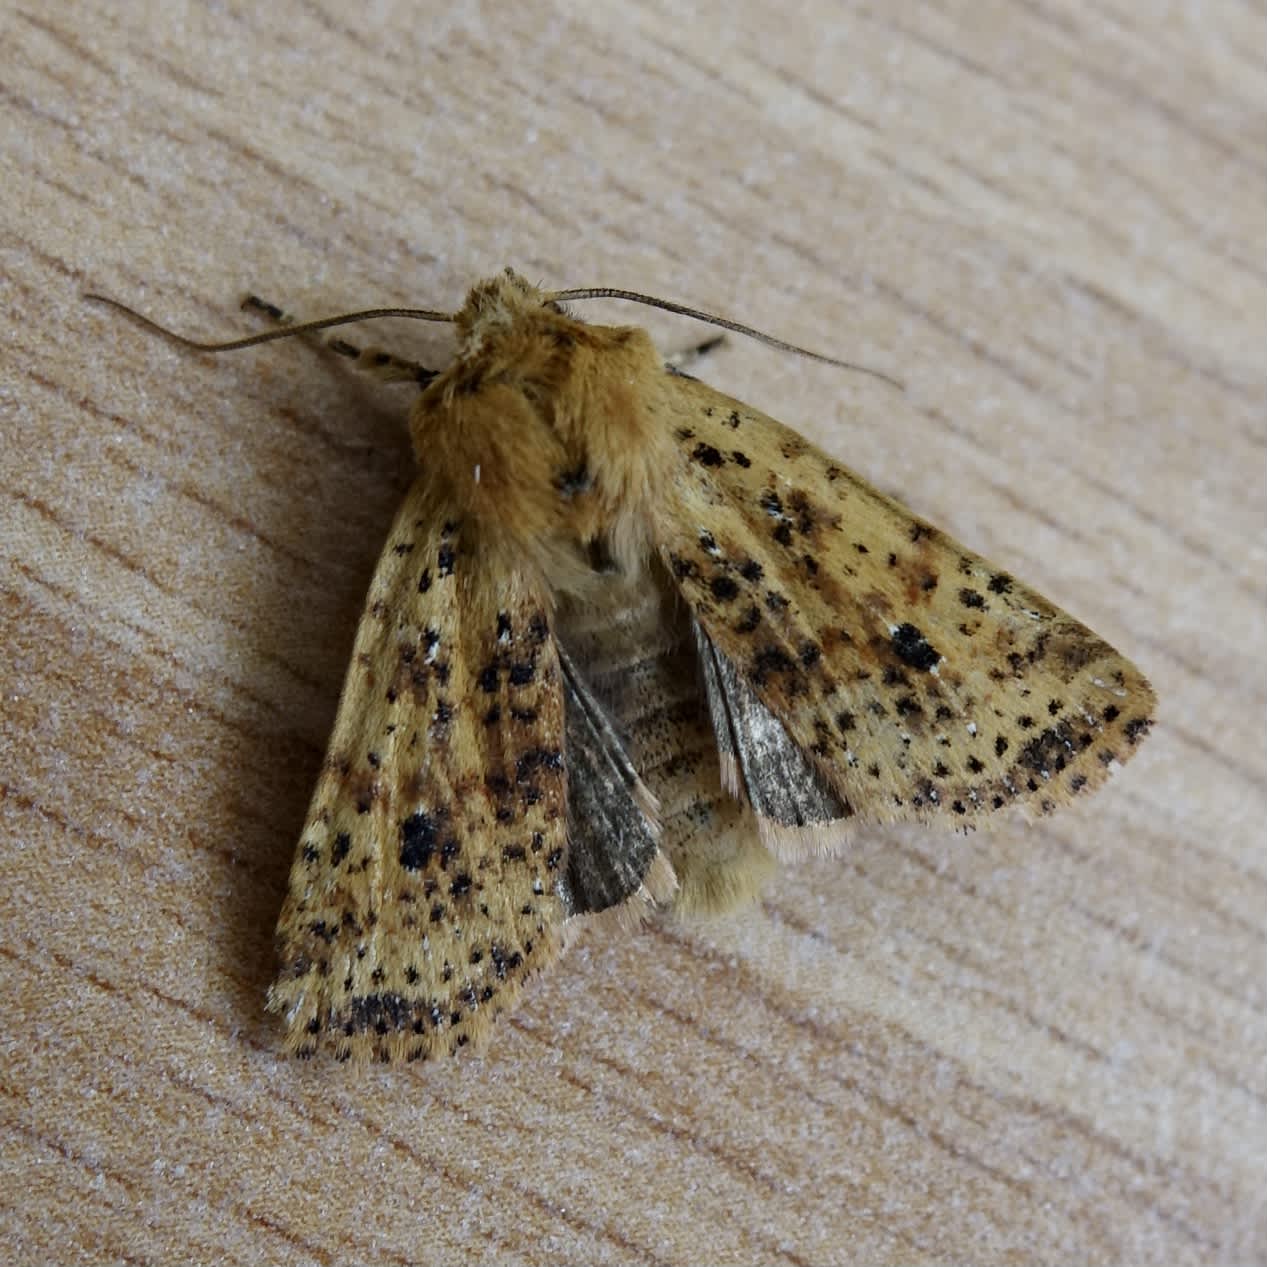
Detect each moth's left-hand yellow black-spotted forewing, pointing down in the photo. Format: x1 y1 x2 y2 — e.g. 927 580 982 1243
270 485 566 1059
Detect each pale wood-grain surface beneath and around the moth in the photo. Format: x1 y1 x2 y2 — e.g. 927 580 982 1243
0 0 1267 1264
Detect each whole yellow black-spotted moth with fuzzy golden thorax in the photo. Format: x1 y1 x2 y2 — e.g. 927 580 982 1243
89 270 1154 1060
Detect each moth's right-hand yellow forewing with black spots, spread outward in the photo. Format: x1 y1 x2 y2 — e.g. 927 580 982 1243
656 379 1154 822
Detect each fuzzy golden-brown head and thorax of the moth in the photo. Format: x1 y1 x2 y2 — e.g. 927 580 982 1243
411 274 673 590
